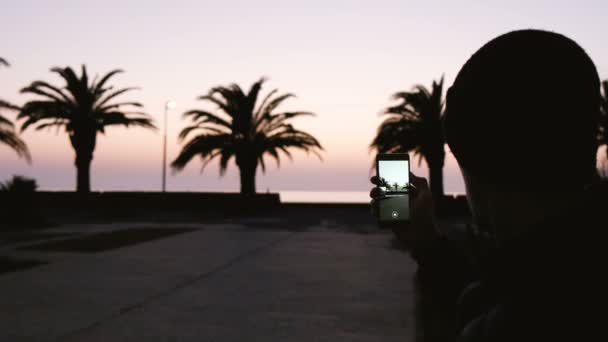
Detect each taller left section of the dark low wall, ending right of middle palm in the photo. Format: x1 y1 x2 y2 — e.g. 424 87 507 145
0 191 280 222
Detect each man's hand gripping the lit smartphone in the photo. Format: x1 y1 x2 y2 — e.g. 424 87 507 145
369 173 439 250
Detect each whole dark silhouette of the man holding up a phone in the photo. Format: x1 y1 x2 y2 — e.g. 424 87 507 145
370 30 606 341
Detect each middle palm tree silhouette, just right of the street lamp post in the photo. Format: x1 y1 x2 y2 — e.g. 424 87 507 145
171 78 323 195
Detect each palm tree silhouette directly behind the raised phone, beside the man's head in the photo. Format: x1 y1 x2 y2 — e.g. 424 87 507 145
370 76 445 203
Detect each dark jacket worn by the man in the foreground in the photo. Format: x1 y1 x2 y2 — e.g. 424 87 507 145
414 187 608 342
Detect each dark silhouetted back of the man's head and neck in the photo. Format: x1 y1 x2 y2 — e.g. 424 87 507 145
444 30 600 238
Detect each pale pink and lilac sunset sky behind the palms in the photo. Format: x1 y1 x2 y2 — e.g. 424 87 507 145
0 0 608 192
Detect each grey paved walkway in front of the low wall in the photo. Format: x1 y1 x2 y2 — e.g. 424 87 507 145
0 224 415 342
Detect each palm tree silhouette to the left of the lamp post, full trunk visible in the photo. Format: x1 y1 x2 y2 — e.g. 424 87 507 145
17 65 156 193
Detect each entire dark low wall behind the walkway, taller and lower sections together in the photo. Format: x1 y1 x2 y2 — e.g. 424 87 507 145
0 191 470 224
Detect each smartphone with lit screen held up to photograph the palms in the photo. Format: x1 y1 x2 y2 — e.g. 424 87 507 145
376 153 410 223
